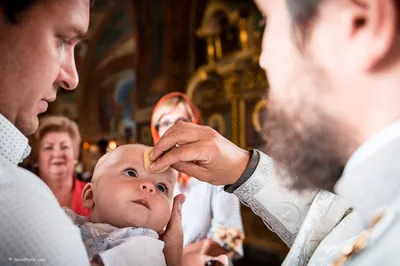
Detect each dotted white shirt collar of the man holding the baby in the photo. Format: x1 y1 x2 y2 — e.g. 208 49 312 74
0 114 31 165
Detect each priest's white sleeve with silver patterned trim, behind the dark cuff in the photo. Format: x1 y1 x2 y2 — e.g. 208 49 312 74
234 150 363 266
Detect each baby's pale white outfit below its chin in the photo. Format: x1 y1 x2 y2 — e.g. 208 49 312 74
63 207 166 266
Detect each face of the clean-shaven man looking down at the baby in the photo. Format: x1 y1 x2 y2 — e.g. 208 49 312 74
0 0 90 135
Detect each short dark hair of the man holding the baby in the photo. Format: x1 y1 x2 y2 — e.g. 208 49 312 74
0 0 38 24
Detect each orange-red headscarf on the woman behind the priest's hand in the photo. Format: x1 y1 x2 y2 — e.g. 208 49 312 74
151 92 203 186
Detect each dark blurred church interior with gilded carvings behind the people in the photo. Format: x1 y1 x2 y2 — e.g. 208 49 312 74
34 0 288 265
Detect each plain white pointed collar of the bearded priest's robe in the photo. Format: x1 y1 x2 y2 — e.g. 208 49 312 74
335 121 400 225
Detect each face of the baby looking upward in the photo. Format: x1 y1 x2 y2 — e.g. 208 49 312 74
90 145 176 232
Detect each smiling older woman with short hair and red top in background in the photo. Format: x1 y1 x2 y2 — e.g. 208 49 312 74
32 116 89 216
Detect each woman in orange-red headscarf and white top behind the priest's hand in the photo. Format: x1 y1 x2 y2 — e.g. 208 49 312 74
151 92 244 264
